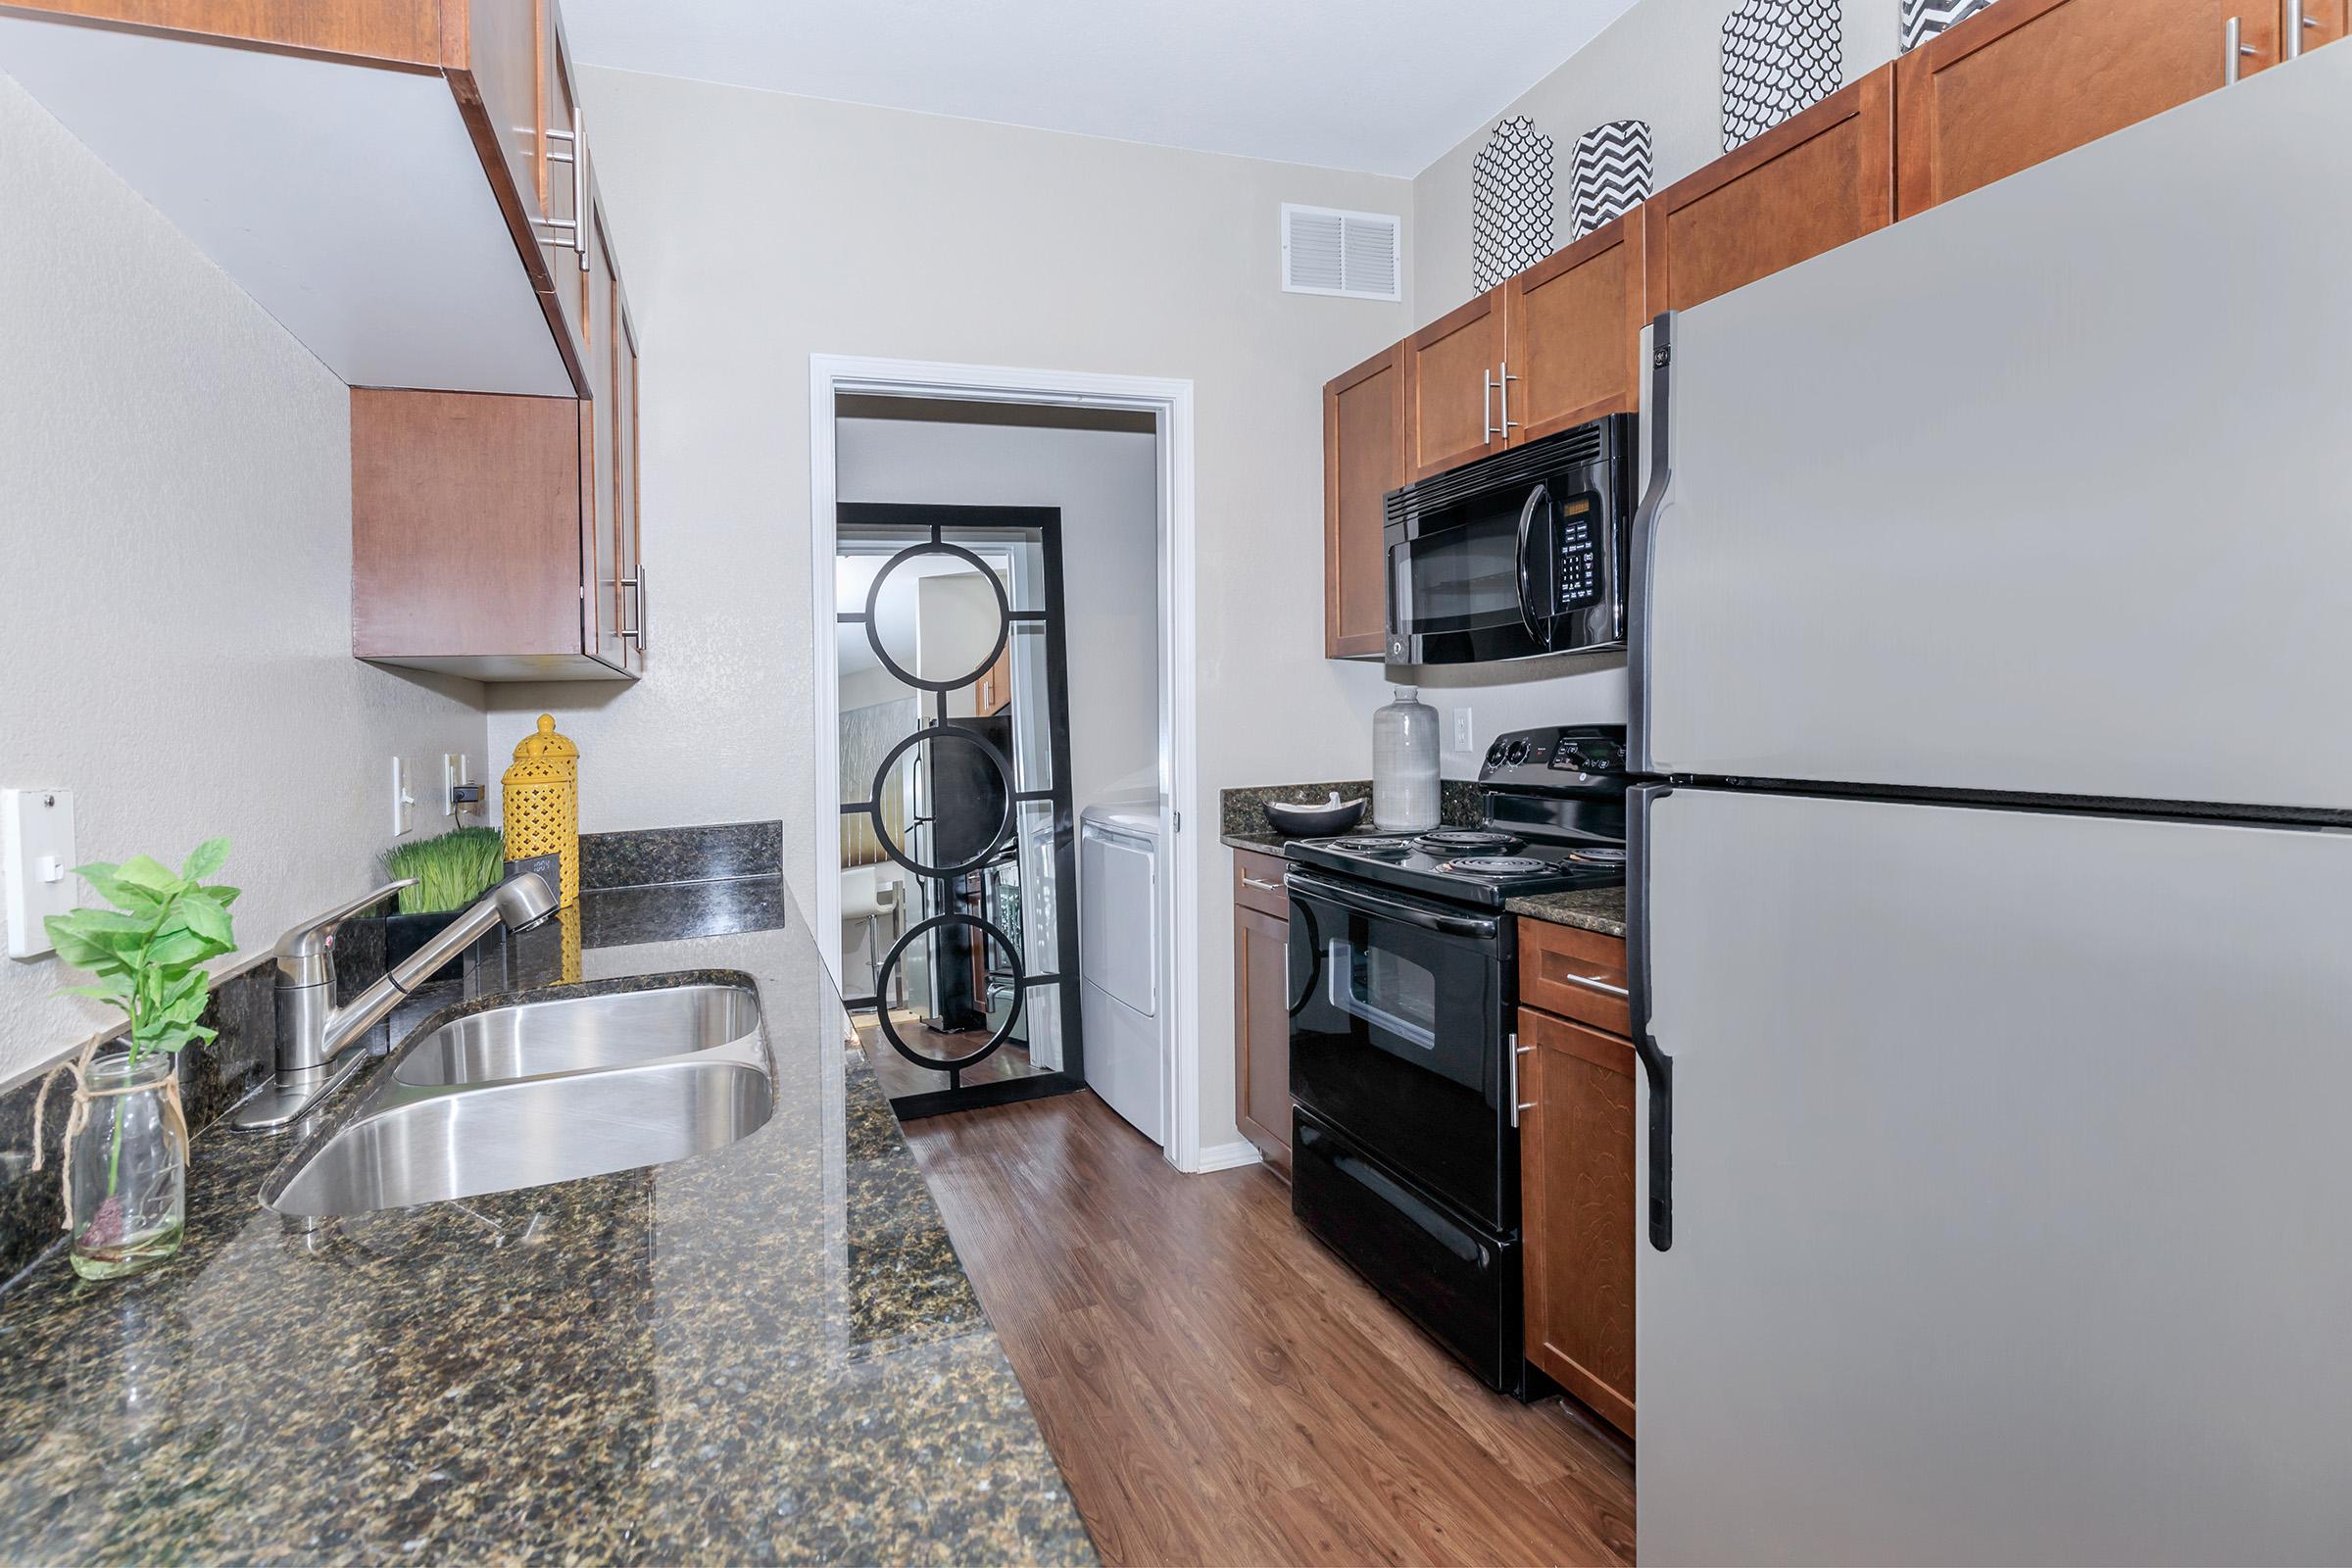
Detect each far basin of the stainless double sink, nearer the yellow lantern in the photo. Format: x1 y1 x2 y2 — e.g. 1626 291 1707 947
393 985 760 1084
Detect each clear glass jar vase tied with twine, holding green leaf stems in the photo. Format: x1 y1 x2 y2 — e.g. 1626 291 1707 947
66 1051 188 1279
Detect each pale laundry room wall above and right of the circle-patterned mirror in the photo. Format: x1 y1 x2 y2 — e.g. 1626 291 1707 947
837 418 1159 811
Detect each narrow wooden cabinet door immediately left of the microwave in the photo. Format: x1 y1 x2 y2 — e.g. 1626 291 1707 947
1324 343 1404 659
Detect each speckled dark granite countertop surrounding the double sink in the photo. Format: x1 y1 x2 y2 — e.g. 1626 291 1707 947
0 877 1094 1563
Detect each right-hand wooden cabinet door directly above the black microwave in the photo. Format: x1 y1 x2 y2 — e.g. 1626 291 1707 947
1503 209 1644 444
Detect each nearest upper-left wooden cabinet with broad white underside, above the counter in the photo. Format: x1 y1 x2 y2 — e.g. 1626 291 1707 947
0 0 595 397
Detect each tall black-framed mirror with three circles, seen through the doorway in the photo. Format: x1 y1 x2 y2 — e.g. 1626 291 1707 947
835 503 1084 1119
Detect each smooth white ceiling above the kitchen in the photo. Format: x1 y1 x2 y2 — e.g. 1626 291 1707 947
560 0 1633 176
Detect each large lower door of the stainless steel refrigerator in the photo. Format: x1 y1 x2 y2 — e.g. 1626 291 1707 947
1637 788 2352 1566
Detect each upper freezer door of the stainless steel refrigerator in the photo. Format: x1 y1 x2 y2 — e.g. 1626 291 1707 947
1637 49 2352 808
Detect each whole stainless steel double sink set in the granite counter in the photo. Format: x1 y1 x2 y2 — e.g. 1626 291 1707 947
261 978 774 1215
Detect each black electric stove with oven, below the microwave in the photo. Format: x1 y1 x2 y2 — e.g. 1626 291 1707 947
1284 726 1625 1398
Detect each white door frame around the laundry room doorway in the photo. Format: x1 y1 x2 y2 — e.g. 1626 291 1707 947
809 355 1223 1171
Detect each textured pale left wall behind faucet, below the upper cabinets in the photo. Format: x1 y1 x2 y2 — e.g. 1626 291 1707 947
0 75 484 1081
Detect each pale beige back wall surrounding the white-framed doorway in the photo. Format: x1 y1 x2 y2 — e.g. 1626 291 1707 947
492 71 1411 1145
